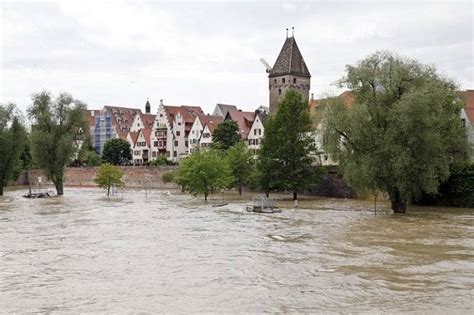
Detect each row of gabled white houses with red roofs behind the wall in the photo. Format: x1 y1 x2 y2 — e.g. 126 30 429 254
88 100 268 164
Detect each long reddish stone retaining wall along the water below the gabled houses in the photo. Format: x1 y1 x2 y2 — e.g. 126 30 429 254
11 166 177 188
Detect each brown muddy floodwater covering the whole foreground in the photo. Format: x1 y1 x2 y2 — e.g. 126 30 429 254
0 189 474 313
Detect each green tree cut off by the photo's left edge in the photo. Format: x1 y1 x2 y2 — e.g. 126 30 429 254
0 104 26 196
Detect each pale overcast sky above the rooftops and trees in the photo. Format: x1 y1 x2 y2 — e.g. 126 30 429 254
0 1 474 112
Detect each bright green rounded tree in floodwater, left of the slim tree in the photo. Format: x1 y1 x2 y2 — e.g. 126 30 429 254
174 150 233 201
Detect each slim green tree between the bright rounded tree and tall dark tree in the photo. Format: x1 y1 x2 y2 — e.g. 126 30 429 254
227 142 254 195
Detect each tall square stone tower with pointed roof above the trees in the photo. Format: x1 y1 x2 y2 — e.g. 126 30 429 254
268 36 311 114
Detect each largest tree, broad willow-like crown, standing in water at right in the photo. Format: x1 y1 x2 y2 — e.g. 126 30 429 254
323 52 468 213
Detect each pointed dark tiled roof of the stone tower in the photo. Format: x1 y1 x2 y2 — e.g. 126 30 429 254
268 36 311 78
